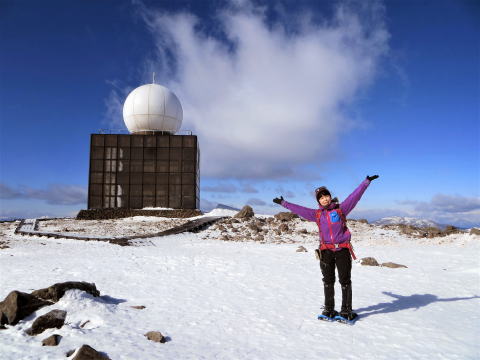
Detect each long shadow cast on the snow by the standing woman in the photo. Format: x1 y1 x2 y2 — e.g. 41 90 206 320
356 291 480 318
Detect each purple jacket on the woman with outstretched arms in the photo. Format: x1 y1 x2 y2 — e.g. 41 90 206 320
281 179 370 244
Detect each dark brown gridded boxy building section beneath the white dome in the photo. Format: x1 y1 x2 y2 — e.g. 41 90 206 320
88 134 200 209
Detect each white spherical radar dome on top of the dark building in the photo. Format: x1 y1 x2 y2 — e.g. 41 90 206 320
123 84 183 134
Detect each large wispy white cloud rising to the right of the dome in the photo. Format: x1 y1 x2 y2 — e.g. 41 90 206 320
140 1 389 178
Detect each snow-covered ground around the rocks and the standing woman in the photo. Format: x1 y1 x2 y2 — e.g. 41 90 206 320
0 214 480 360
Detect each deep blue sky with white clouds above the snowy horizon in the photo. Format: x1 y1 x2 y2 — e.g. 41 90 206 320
0 0 480 226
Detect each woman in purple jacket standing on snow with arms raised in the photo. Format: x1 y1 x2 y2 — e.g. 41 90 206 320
273 175 378 321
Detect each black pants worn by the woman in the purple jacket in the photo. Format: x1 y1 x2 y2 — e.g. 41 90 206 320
320 249 352 312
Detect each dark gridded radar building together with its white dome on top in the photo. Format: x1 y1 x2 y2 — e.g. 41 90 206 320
88 83 200 209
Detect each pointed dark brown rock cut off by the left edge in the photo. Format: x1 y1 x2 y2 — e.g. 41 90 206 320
0 290 52 325
